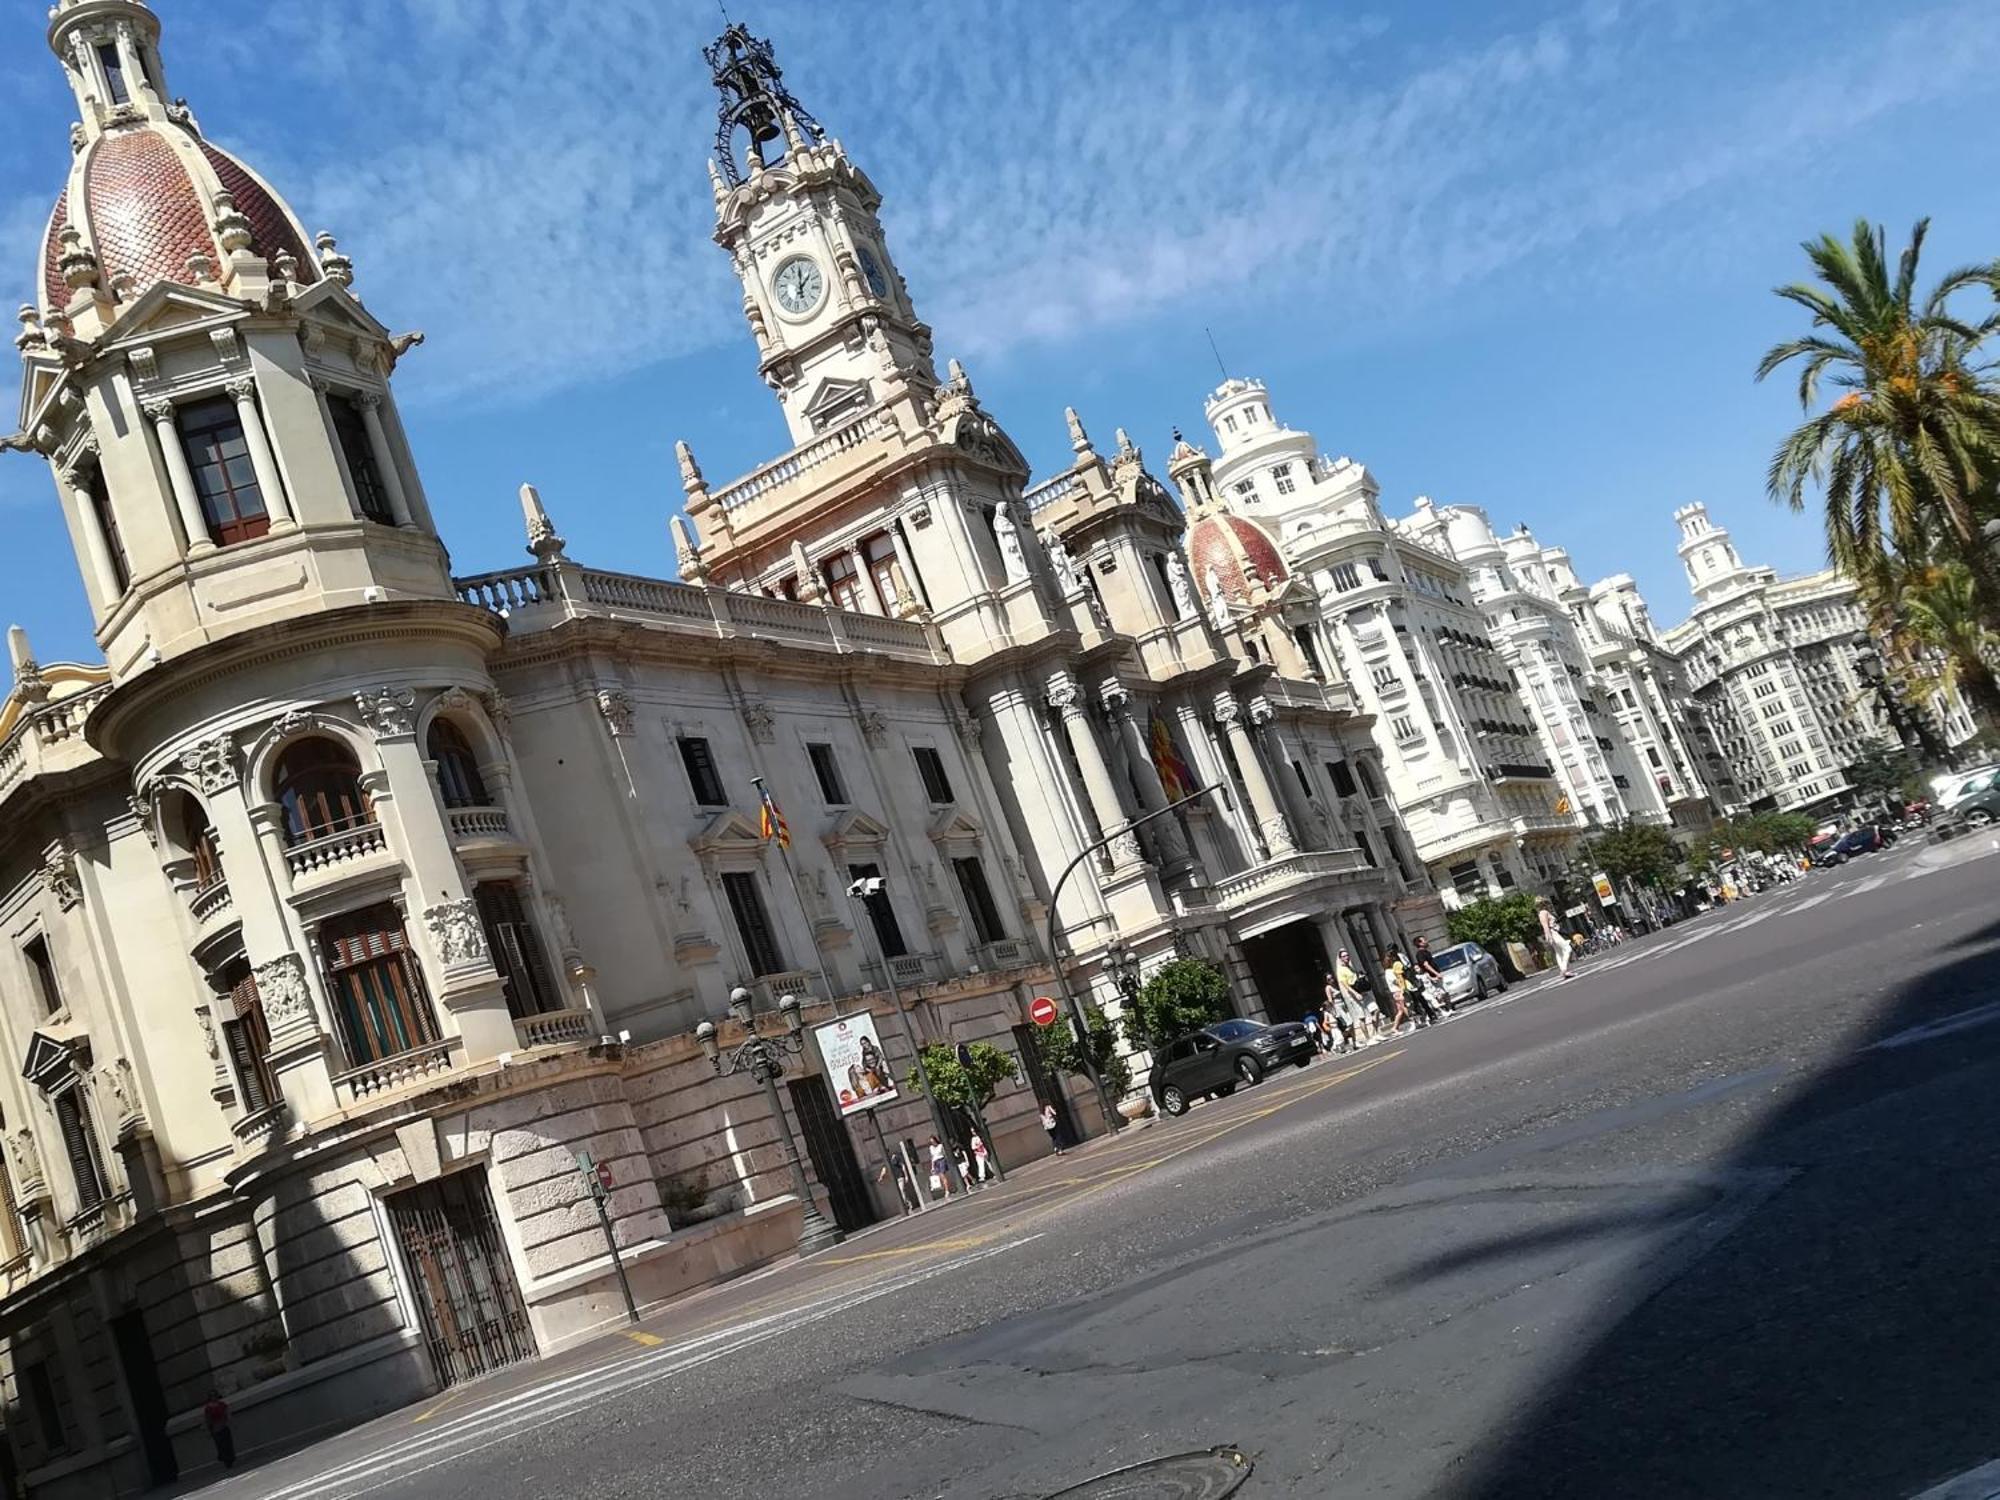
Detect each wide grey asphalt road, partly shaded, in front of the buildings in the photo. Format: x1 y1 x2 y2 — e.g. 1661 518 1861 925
204 838 2000 1500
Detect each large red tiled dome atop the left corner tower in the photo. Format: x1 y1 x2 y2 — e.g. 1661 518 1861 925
42 126 318 306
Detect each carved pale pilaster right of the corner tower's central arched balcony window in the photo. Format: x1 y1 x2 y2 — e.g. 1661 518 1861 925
354 688 518 1062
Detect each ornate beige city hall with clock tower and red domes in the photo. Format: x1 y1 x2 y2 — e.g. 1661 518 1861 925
0 0 1438 1496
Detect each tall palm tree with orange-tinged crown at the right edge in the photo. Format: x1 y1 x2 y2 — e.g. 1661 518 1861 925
1756 218 2000 620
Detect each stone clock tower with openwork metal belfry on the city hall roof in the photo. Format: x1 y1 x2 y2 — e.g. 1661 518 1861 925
702 26 938 442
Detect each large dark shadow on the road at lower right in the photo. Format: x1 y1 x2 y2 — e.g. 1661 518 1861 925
1456 922 2000 1500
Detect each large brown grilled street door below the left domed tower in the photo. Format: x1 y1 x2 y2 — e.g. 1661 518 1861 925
386 1170 534 1386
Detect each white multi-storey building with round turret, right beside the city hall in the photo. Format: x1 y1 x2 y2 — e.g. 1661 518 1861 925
1190 380 1552 906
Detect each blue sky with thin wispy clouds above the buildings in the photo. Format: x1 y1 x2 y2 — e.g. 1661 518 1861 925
0 0 2000 660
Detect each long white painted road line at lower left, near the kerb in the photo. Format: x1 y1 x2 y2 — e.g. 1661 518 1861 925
262 1234 1042 1500
